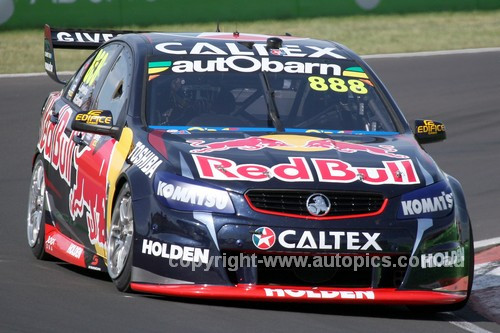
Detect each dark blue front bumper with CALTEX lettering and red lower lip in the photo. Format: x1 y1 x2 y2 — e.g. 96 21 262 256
132 192 470 298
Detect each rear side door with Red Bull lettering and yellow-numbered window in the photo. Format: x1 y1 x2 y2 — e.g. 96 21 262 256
38 44 122 245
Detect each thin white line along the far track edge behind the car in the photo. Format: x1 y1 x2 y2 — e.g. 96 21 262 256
0 47 500 79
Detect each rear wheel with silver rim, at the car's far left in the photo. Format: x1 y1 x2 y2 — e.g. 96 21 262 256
26 155 51 260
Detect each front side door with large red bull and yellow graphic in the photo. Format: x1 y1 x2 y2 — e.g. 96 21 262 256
69 45 133 256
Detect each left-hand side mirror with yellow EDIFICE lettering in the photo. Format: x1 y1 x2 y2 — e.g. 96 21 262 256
71 110 120 139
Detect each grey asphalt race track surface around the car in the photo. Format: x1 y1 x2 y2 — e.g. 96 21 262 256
0 52 500 333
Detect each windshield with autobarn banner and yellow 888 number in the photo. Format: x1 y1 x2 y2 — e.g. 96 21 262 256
146 57 396 132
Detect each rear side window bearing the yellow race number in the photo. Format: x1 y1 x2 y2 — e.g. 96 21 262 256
73 43 123 111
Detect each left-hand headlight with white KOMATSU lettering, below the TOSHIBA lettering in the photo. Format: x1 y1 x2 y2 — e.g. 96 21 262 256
154 172 234 214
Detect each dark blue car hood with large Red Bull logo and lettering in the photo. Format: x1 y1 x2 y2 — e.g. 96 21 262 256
148 130 444 198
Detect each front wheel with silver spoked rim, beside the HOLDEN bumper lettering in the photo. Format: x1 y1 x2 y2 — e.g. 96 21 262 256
107 183 134 292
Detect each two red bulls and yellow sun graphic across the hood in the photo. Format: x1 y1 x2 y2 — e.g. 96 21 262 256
187 135 408 159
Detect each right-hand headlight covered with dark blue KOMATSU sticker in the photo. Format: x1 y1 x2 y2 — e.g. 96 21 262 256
398 181 454 219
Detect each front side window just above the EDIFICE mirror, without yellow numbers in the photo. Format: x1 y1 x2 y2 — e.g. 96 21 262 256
93 47 132 122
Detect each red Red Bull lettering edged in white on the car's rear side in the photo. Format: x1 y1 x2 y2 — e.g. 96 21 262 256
38 97 76 185
